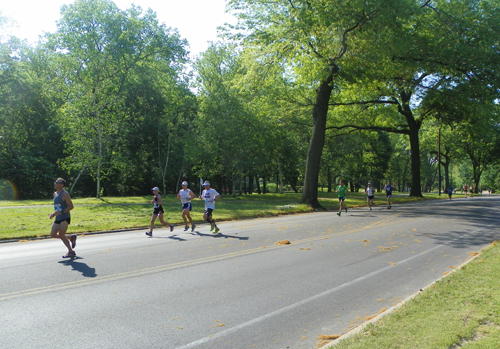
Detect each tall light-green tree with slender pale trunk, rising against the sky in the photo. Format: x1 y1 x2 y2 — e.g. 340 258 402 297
49 0 186 197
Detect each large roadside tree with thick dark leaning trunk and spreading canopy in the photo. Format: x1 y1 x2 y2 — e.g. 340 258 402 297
228 0 418 208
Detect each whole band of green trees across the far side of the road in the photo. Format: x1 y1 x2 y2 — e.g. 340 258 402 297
0 0 500 204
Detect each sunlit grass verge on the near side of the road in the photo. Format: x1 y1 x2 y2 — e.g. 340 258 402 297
332 243 500 349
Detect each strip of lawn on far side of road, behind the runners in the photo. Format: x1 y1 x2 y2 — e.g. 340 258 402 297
0 192 433 240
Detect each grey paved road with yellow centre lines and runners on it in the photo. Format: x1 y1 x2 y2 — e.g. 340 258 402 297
0 197 500 349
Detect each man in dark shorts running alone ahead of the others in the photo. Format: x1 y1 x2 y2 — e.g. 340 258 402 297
50 178 76 258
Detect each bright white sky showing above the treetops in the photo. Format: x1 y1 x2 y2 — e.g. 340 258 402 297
0 0 236 58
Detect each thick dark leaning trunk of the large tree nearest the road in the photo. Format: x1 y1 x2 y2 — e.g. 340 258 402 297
302 70 334 209
